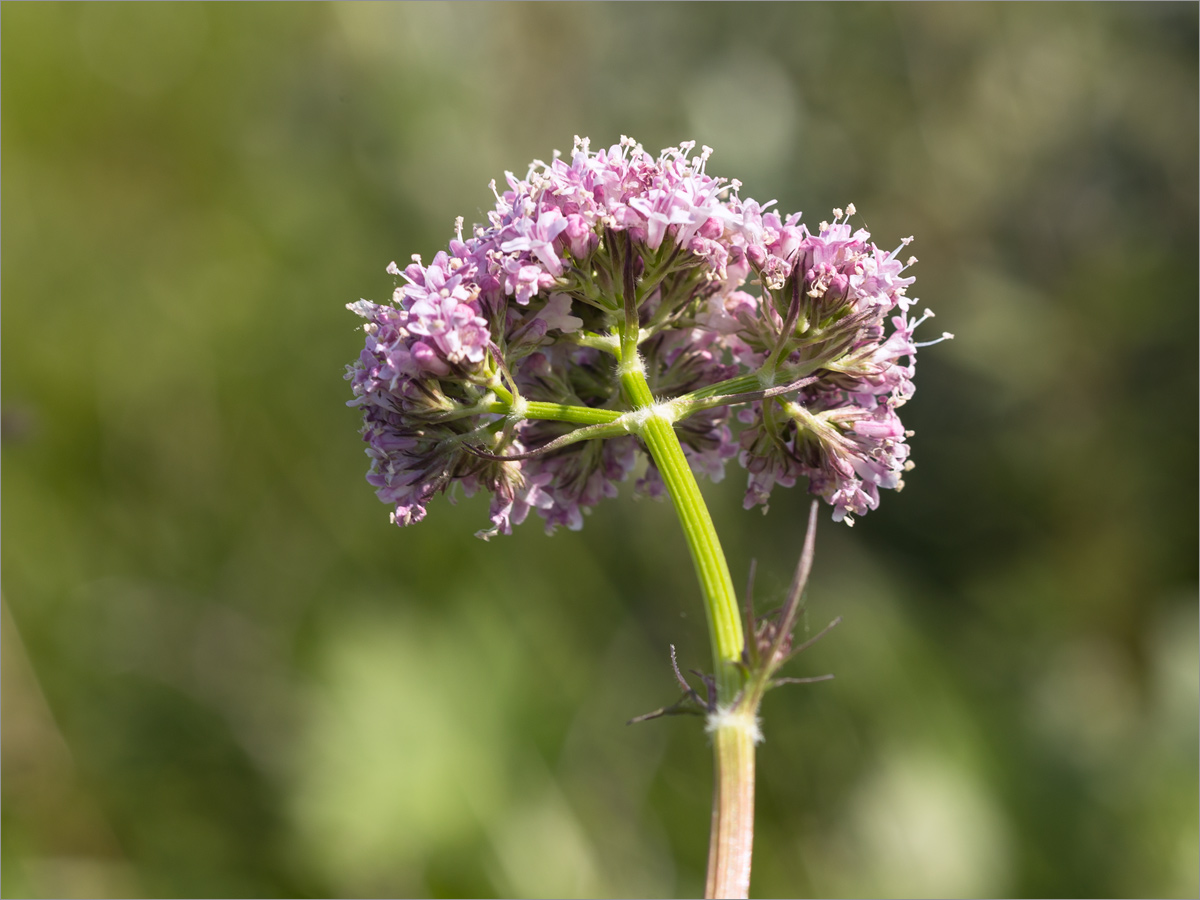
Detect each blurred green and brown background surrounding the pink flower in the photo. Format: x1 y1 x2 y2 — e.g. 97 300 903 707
0 2 1200 896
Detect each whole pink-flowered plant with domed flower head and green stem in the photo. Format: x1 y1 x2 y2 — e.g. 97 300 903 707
347 138 949 896
